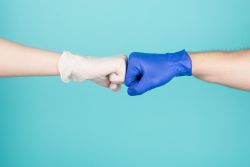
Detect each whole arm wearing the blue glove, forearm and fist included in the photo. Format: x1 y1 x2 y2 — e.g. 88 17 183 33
125 50 250 96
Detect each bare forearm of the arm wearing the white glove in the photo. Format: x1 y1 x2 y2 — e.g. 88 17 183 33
0 39 60 76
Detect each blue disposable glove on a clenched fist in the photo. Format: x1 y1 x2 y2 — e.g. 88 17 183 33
125 50 192 96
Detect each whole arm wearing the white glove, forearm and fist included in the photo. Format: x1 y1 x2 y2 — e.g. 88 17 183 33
0 38 127 91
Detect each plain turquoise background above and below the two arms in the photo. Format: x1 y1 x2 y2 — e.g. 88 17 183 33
0 0 250 167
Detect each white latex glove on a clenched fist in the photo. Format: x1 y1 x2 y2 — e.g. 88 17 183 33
58 51 127 91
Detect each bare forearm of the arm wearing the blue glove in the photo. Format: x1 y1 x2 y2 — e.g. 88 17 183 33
189 50 250 90
